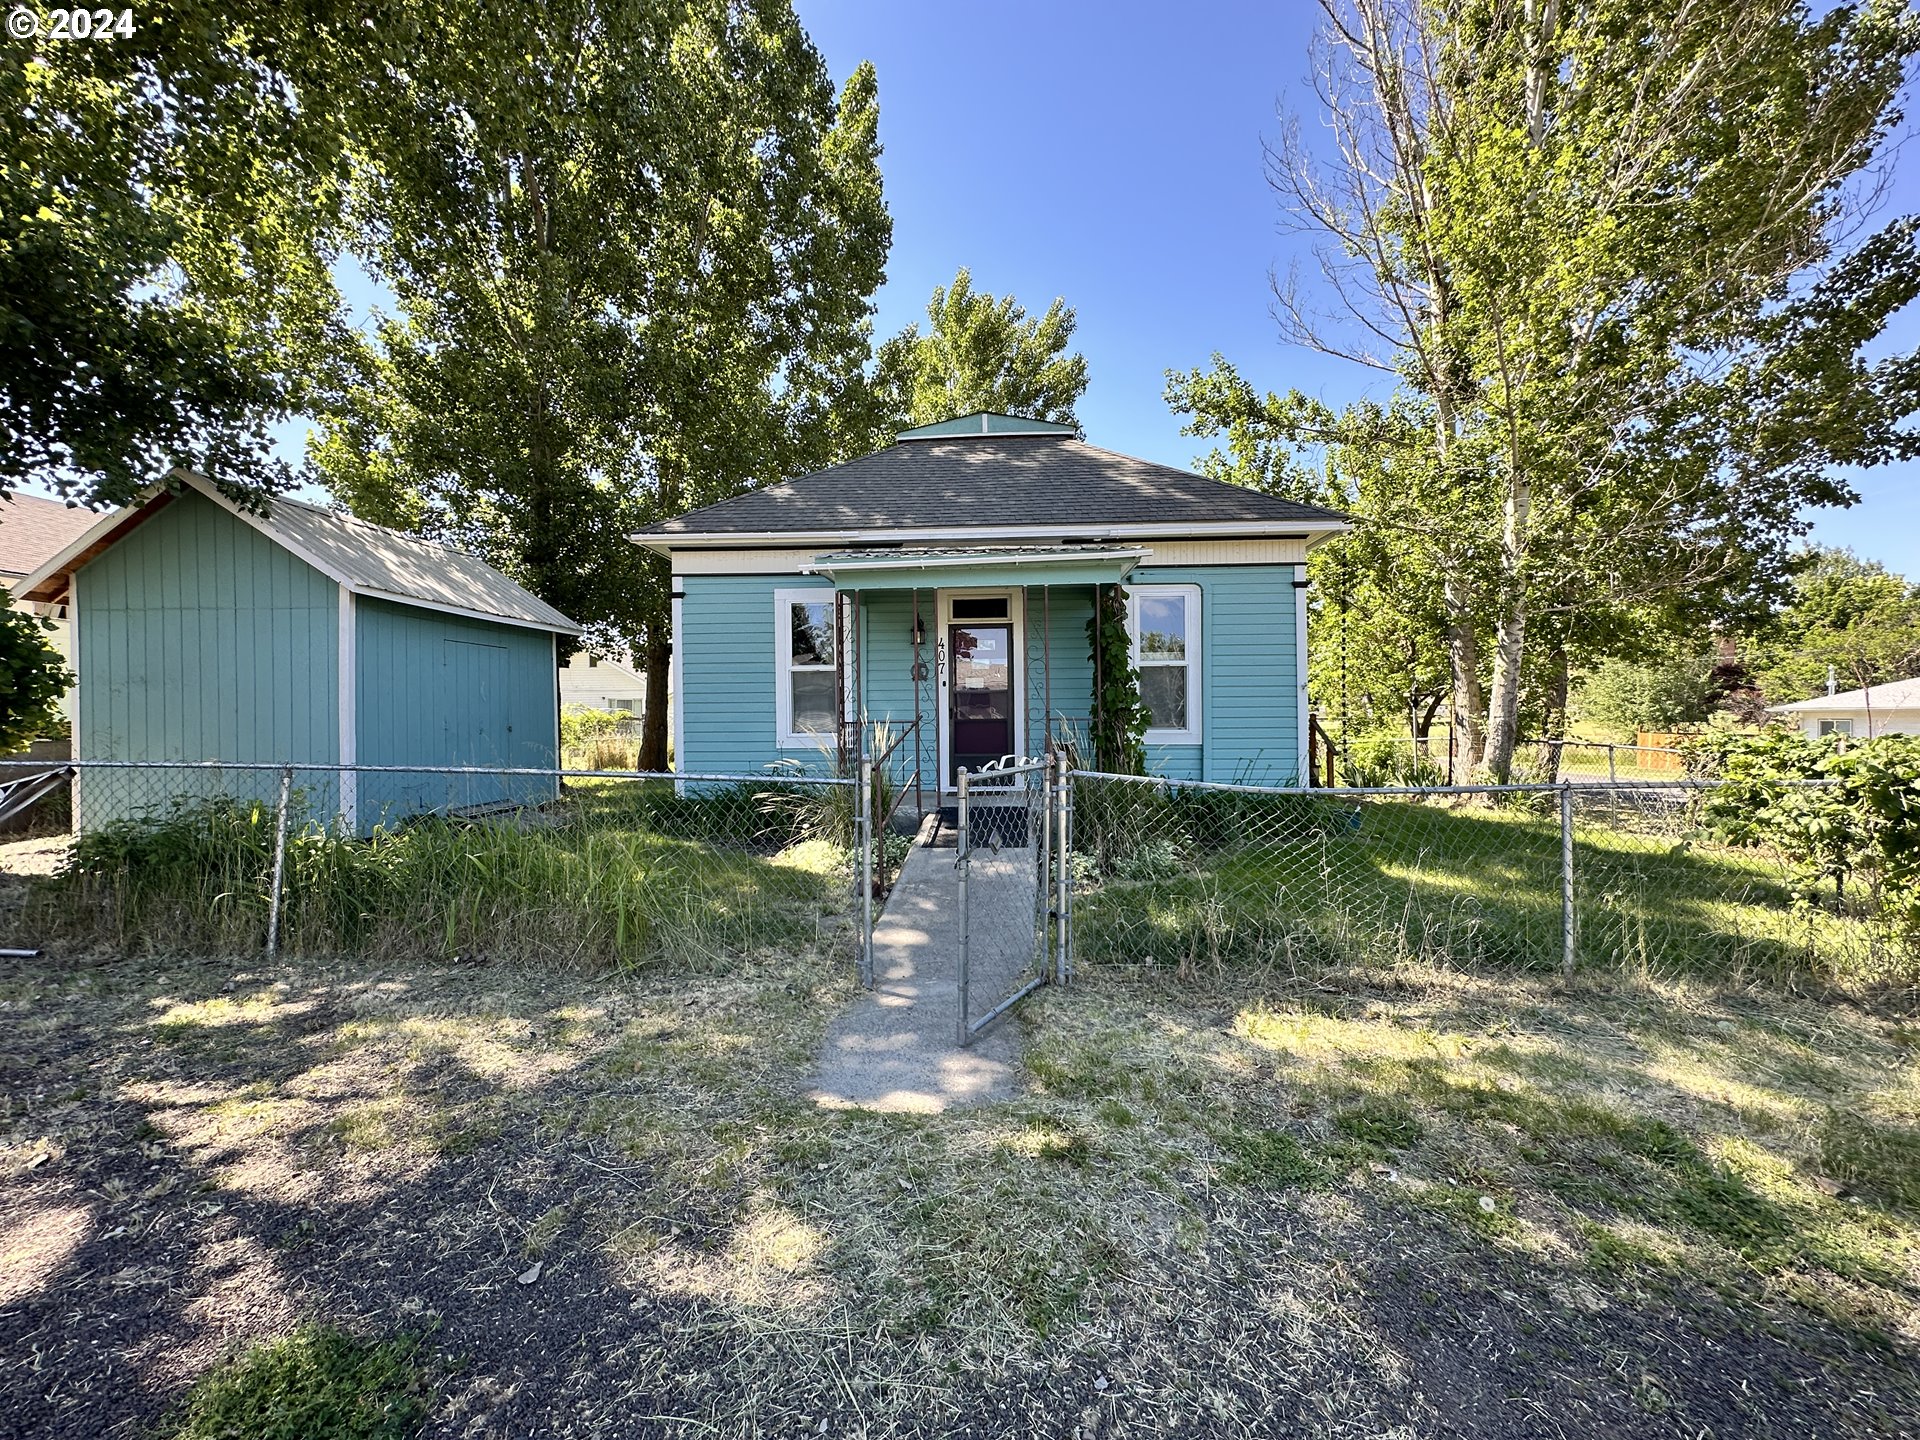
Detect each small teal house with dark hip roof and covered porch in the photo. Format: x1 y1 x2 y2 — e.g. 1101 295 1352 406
636 415 1348 793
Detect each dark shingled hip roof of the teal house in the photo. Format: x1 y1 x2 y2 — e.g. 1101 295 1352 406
634 434 1348 549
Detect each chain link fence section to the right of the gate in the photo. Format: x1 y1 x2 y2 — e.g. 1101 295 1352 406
1068 772 1920 989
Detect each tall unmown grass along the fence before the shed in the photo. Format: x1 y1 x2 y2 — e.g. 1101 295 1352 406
27 781 851 968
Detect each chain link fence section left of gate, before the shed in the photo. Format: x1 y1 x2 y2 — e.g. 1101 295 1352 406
0 762 872 966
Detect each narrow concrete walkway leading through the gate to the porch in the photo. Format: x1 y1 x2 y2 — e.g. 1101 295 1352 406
812 845 1020 1114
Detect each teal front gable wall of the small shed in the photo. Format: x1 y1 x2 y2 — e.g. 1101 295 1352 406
73 493 340 826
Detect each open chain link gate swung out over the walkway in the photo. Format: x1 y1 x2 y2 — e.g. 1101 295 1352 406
954 756 1066 1044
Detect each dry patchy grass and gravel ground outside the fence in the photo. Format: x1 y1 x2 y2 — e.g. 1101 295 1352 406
0 929 1920 1438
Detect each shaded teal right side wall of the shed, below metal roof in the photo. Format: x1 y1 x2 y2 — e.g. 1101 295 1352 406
353 597 559 829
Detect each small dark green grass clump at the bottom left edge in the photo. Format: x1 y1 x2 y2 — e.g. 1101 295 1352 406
157 1325 426 1440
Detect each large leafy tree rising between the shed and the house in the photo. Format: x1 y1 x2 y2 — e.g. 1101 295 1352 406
313 0 891 766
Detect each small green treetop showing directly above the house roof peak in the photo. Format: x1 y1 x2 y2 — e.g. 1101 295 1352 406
872 267 1087 432
